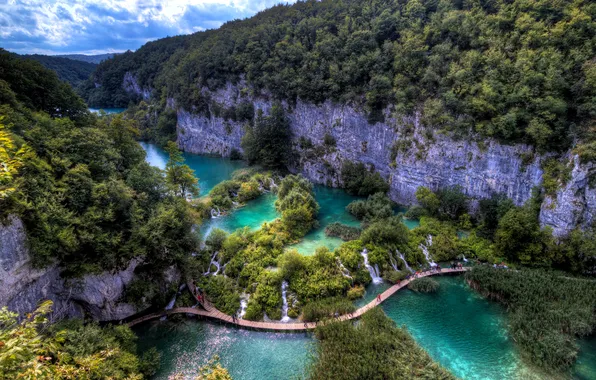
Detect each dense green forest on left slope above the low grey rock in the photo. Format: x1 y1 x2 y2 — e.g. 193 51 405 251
0 52 198 282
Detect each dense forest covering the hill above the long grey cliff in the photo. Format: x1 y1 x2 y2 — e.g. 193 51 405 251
85 0 596 154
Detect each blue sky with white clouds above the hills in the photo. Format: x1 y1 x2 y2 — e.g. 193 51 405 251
0 0 293 55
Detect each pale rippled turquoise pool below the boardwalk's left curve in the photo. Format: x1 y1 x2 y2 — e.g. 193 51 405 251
134 319 314 380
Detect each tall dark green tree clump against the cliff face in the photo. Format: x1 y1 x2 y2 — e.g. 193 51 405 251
242 103 291 168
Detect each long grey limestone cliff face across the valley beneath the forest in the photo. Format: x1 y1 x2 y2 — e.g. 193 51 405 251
178 82 596 236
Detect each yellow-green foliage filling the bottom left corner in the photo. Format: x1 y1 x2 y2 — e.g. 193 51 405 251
0 301 159 379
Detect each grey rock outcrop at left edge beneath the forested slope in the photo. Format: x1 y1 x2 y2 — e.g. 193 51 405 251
0 216 138 321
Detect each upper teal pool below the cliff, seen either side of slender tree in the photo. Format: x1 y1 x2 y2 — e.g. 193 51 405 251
140 142 247 195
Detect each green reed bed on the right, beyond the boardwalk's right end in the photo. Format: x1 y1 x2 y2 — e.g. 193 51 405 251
466 266 596 370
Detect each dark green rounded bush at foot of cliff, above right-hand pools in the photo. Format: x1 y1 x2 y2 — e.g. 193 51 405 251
341 161 389 197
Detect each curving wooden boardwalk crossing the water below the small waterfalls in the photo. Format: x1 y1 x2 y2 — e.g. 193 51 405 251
128 267 471 332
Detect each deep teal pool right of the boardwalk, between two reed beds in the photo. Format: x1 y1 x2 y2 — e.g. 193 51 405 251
383 276 533 380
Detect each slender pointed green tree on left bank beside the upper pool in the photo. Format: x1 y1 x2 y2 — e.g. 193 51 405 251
166 141 199 197
